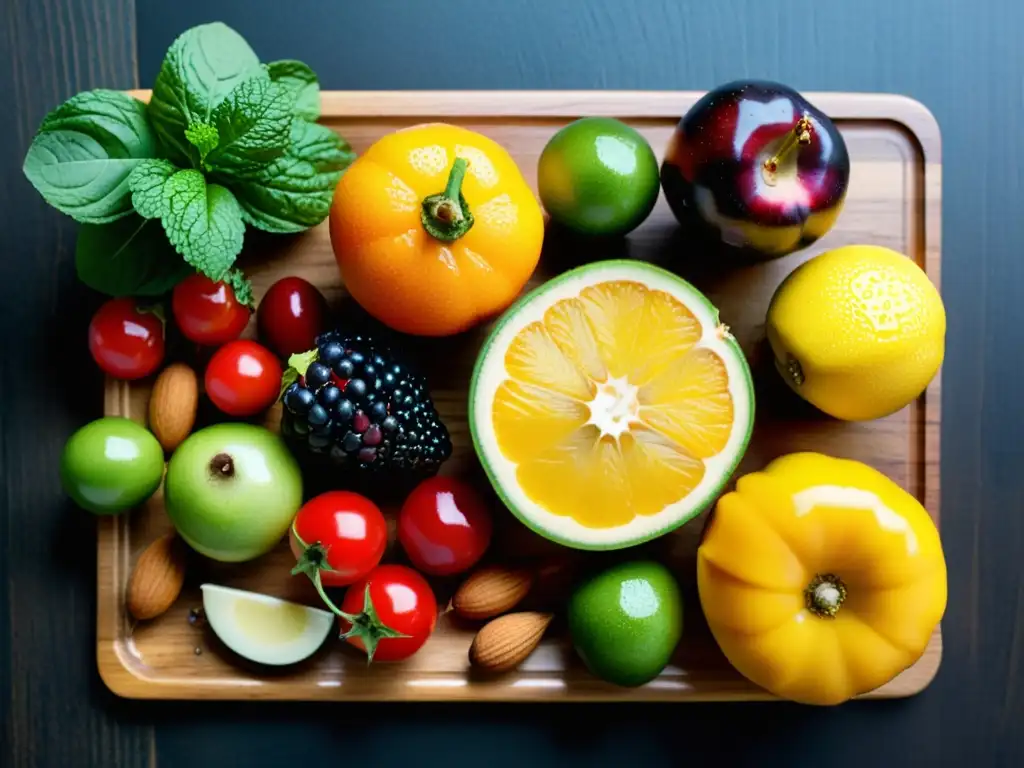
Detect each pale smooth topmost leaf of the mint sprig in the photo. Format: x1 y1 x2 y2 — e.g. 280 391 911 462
148 22 269 166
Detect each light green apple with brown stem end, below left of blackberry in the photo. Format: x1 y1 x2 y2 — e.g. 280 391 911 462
164 423 302 562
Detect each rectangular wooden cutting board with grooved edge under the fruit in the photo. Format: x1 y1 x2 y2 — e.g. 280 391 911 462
96 91 942 701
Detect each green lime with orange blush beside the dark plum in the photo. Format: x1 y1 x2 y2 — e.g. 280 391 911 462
537 118 660 236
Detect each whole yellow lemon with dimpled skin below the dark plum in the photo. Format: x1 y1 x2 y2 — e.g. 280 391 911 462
767 246 946 421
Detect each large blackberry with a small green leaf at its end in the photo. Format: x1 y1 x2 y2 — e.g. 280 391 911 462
281 331 452 483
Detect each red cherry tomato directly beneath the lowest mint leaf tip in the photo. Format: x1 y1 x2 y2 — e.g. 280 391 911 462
171 274 250 346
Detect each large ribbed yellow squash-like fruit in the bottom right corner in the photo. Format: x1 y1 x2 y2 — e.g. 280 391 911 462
697 453 947 705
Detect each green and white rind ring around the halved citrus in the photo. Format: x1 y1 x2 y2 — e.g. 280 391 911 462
468 259 755 551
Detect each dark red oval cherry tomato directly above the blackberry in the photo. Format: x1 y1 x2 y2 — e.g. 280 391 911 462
256 278 328 359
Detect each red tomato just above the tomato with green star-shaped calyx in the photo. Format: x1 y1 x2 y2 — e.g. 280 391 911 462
289 490 387 587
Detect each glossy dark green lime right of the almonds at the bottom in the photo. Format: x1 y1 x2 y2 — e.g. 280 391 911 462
568 560 683 686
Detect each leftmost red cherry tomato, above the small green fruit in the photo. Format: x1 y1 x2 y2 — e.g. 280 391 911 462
89 299 164 379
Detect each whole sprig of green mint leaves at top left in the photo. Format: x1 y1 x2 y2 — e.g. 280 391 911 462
24 23 355 296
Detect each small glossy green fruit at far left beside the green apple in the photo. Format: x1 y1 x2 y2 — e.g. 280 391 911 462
60 416 164 515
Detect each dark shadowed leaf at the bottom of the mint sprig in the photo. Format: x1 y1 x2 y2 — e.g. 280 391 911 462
75 215 194 296
